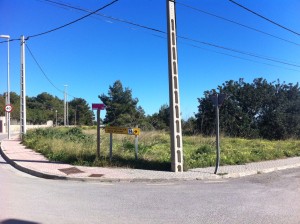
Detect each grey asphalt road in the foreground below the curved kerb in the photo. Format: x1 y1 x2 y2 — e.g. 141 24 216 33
0 146 300 224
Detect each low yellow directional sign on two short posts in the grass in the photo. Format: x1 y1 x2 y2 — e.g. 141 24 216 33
105 126 141 161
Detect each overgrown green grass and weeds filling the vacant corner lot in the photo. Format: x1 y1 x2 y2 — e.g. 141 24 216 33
23 128 300 170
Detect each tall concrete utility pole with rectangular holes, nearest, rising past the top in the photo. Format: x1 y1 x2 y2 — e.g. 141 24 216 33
167 0 183 172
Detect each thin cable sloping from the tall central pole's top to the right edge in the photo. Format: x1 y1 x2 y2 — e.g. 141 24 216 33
176 1 300 46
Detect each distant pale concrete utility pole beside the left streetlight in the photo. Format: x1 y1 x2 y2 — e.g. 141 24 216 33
20 36 26 137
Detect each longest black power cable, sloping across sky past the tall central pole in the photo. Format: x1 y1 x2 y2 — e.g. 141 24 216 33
37 0 300 67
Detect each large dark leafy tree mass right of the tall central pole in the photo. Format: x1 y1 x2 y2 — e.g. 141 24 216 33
196 78 300 139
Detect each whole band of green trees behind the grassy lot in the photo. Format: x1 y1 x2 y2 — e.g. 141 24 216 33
0 78 300 139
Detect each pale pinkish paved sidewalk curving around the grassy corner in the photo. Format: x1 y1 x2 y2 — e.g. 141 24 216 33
0 136 300 182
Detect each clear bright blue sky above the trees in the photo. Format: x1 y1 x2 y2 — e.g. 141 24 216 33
0 0 300 119
